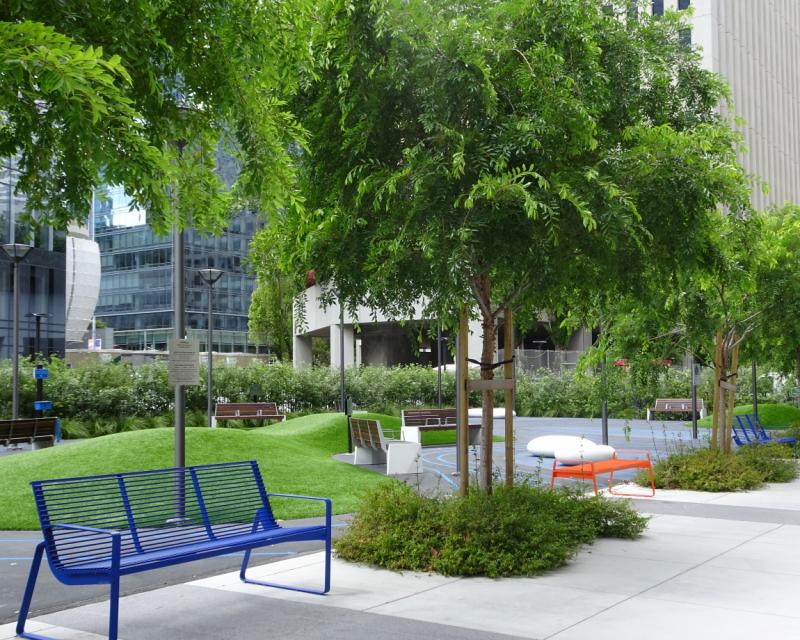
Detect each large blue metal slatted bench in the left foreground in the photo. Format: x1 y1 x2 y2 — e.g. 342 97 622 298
17 461 331 640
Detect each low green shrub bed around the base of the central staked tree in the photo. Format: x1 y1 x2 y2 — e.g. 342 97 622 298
335 484 647 578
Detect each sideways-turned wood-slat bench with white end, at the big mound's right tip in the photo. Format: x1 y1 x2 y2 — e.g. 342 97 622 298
350 418 422 475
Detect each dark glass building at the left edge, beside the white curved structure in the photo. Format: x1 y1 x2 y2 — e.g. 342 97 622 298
0 158 66 358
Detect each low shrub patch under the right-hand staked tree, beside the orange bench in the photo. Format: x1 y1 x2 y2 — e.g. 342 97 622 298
636 444 797 491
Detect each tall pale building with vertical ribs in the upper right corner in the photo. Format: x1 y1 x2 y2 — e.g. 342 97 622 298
652 0 800 209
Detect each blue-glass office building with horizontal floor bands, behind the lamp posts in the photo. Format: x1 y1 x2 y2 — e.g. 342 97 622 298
94 188 261 353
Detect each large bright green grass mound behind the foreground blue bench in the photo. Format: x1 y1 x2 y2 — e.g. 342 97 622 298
0 414 391 529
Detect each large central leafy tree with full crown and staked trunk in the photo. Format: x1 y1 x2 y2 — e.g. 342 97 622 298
272 0 748 490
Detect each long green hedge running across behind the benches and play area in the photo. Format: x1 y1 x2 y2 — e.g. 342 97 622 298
0 359 786 421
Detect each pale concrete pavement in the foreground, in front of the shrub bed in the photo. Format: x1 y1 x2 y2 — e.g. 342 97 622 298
0 481 800 640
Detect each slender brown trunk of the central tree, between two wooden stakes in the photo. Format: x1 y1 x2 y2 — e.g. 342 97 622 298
475 274 497 493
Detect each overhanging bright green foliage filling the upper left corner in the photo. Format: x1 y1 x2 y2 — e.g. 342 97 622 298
0 0 311 231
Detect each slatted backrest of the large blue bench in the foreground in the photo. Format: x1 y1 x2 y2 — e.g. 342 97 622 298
31 461 278 569
